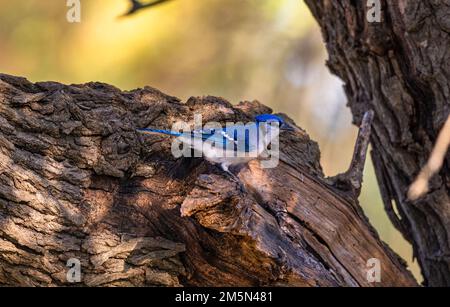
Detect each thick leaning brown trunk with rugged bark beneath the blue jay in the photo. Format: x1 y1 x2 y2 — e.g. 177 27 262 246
0 75 415 286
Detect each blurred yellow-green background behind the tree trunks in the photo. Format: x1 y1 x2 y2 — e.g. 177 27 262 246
0 0 422 281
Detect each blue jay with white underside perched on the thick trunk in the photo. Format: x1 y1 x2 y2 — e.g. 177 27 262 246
137 114 294 181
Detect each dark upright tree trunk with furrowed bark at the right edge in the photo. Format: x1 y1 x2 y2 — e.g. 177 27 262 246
306 0 450 286
